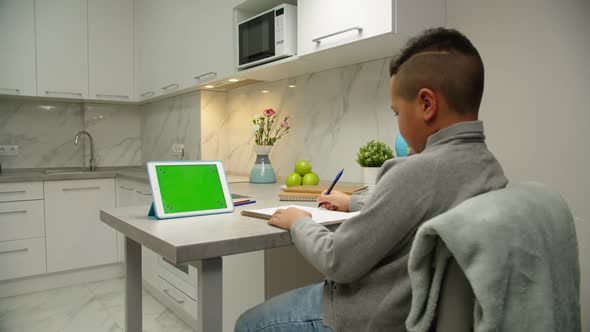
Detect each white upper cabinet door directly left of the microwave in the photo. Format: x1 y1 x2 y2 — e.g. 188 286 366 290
183 0 240 85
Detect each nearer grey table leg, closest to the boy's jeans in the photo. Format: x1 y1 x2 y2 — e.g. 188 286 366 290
197 257 223 332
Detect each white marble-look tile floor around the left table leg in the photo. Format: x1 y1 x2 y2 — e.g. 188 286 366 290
0 278 192 332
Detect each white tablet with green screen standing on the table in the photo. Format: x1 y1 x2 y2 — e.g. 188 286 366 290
147 161 234 219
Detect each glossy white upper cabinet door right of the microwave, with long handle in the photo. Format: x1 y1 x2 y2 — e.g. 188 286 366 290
297 0 395 55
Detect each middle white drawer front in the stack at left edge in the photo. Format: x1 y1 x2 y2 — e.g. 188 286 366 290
0 200 45 241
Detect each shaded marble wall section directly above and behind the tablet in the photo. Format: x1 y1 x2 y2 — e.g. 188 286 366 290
140 91 201 161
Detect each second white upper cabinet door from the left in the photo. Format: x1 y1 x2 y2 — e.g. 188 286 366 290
35 0 88 99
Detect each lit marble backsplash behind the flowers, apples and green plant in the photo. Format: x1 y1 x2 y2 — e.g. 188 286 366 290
202 59 397 181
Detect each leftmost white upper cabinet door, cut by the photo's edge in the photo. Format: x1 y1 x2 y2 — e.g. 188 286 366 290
0 0 37 96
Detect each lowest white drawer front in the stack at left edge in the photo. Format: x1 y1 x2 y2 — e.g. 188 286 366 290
0 238 47 280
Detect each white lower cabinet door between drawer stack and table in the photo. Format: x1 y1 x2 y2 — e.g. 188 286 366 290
44 179 117 272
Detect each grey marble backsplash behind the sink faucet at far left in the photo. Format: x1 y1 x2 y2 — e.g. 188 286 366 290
0 98 142 168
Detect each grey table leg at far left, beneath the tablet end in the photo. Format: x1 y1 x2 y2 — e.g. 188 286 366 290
125 237 143 332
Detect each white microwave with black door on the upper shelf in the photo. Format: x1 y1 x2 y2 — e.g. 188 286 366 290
237 4 297 69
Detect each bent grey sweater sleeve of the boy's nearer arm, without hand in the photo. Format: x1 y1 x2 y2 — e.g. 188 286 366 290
291 163 435 283
